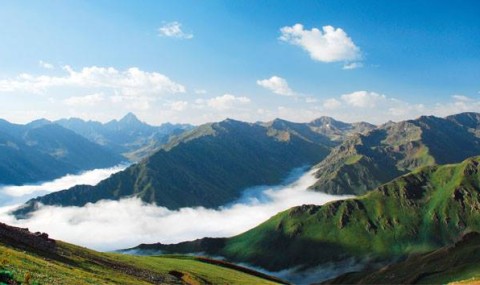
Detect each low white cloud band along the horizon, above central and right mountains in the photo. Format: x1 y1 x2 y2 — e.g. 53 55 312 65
156 90 480 124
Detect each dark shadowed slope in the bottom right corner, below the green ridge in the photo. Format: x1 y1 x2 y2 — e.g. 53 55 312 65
325 232 480 284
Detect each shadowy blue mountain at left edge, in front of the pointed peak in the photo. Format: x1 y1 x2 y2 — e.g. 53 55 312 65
0 120 124 185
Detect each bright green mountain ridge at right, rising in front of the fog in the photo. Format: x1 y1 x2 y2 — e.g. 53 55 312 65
136 157 480 277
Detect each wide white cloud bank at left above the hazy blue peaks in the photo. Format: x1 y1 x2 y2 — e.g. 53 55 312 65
0 65 186 113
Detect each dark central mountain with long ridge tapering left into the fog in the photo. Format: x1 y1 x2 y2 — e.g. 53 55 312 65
16 119 336 214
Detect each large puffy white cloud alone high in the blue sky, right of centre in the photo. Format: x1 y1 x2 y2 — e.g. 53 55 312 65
279 24 362 64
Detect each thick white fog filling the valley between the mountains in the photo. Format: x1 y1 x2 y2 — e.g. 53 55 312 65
0 165 351 251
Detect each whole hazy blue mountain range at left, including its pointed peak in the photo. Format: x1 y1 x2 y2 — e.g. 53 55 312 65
0 113 193 185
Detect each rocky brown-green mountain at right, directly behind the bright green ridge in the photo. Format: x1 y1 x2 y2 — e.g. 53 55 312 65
312 113 480 194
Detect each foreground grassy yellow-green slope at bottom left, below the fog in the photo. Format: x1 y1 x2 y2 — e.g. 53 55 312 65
0 223 282 284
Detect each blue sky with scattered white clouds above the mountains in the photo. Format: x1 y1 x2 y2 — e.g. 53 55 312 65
0 0 480 124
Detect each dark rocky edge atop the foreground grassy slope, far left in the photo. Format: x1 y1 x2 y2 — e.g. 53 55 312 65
0 223 56 252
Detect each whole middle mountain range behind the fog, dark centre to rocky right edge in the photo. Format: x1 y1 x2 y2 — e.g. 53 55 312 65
16 113 480 214
